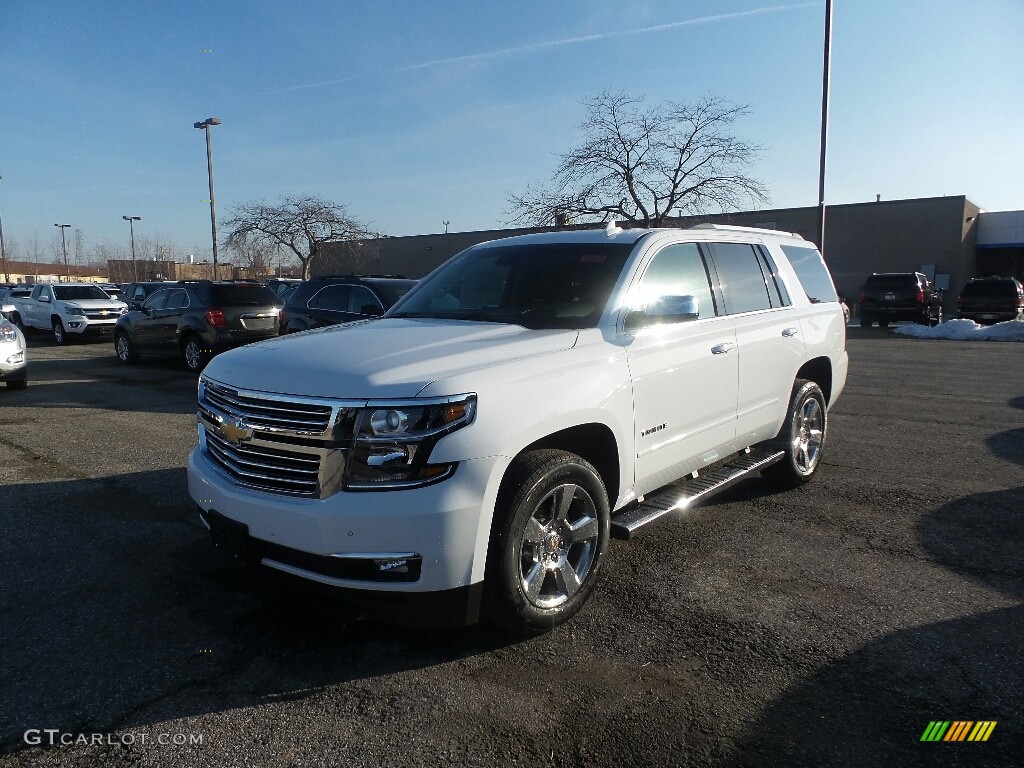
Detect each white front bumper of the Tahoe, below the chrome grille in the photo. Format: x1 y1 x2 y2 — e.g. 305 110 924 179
188 438 498 624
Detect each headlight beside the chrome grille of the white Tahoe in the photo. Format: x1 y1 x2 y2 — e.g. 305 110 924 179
345 394 476 490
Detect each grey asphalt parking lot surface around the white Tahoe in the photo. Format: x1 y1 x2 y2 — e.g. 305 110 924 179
0 329 1024 766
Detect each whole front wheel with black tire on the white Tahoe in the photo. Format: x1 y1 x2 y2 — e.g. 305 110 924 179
483 451 611 635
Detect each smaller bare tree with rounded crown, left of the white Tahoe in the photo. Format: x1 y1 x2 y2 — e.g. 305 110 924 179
223 197 370 280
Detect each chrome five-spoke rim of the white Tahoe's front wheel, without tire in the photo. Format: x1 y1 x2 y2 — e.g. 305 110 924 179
519 483 600 608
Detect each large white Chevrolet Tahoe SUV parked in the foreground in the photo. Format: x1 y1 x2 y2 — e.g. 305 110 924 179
188 225 848 634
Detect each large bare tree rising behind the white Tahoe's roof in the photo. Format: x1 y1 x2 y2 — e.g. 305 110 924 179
508 91 768 226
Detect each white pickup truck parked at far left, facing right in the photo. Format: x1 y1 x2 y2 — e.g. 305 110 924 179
12 283 128 344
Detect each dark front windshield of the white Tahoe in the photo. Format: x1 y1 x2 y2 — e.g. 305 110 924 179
389 243 632 329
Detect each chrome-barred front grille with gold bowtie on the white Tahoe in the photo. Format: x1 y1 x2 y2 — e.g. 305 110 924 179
198 377 365 499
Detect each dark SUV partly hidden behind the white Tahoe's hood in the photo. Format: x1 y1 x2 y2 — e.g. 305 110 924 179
281 274 416 334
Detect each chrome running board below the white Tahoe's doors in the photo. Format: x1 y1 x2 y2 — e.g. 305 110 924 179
611 449 784 539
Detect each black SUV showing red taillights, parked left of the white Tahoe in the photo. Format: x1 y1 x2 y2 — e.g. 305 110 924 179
114 280 281 372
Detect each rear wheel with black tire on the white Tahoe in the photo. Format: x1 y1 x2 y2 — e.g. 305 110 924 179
762 379 828 487
